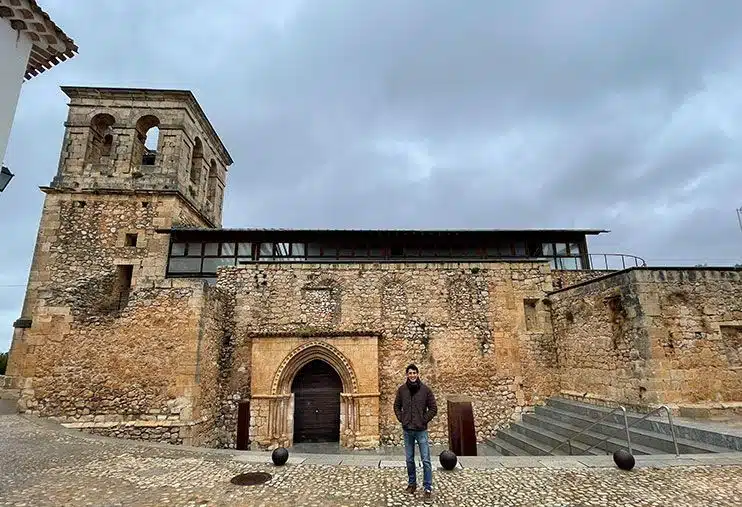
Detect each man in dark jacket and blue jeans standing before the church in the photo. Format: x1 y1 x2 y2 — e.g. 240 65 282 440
394 364 438 499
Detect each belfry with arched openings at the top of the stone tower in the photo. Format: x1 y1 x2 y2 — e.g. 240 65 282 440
50 87 232 227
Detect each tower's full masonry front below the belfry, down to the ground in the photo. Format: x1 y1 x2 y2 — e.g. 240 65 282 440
8 191 212 446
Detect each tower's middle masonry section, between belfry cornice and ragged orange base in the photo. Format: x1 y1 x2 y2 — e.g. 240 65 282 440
9 191 209 330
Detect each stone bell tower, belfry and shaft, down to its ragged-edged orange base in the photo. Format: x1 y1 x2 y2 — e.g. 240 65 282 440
7 87 232 388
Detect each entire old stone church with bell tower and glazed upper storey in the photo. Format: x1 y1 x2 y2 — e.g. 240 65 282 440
7 87 742 449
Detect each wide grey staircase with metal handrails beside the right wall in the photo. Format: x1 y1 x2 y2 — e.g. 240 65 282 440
486 397 742 456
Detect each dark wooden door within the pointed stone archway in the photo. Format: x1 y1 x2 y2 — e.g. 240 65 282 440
291 360 343 443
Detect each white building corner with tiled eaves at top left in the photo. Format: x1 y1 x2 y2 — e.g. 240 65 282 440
0 0 77 173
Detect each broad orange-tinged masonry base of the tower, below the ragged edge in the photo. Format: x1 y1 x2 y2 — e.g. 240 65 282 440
21 280 202 422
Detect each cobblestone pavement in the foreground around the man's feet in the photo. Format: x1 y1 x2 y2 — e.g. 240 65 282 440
0 415 742 507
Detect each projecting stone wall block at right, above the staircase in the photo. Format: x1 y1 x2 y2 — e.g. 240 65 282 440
549 269 742 405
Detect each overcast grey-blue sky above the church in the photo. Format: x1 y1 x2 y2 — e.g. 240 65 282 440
0 0 742 351
